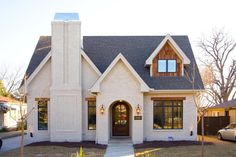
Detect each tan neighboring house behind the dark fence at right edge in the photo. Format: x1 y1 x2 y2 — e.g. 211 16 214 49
206 99 236 123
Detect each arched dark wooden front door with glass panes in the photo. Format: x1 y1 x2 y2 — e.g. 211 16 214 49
112 103 129 136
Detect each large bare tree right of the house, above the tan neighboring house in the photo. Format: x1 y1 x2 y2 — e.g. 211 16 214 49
198 30 236 104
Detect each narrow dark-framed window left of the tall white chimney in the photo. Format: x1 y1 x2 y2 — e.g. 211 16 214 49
38 101 48 130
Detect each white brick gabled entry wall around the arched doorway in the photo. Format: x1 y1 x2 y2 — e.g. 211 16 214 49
96 61 143 144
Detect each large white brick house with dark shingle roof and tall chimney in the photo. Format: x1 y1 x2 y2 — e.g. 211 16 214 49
21 13 203 144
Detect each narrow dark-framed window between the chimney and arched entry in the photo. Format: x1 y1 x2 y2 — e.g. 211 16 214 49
88 101 96 130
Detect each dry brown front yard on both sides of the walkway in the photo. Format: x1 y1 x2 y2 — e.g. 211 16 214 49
0 137 236 157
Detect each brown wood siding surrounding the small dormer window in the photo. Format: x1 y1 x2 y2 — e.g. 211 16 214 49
150 41 183 76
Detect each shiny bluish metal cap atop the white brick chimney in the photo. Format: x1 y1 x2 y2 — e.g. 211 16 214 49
54 13 79 21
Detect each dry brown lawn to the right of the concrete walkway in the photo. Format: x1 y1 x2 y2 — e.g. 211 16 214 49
135 137 236 157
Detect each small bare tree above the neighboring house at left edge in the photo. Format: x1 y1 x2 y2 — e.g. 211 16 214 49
0 66 22 96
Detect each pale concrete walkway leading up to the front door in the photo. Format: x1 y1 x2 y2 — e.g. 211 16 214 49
104 139 134 157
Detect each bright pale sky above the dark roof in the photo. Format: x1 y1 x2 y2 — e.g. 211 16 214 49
0 0 236 72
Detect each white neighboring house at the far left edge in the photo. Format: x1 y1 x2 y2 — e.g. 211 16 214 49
0 96 27 129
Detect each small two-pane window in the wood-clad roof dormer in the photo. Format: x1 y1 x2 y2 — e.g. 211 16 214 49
157 59 176 72
